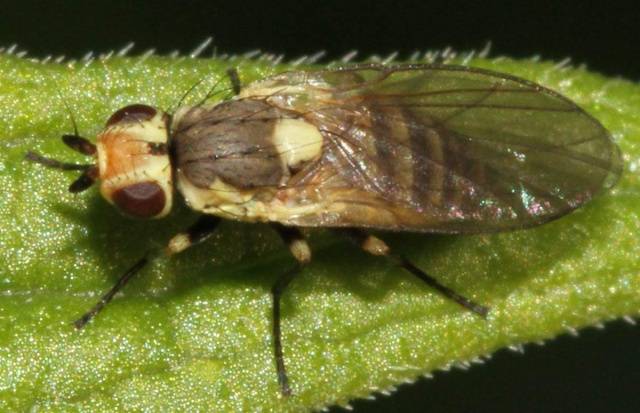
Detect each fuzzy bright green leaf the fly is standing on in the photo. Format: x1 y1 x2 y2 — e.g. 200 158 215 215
0 55 640 412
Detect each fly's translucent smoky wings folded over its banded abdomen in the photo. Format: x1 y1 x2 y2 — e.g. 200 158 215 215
248 65 622 233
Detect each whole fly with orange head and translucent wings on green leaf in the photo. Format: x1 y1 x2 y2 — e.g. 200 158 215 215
27 65 622 395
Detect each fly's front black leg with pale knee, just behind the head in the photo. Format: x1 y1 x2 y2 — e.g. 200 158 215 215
73 215 220 329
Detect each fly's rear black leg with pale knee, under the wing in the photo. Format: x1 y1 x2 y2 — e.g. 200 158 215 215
338 229 489 318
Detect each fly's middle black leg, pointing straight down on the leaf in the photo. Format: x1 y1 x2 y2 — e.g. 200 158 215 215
271 224 311 396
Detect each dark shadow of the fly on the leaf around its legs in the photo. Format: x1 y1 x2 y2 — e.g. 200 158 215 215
52 195 448 312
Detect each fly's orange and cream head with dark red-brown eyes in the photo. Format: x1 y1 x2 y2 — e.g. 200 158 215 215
96 105 173 218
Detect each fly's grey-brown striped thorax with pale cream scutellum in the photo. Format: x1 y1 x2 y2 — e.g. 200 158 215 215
172 99 322 220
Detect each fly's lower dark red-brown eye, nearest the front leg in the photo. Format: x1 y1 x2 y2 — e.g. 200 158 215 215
112 182 166 218
